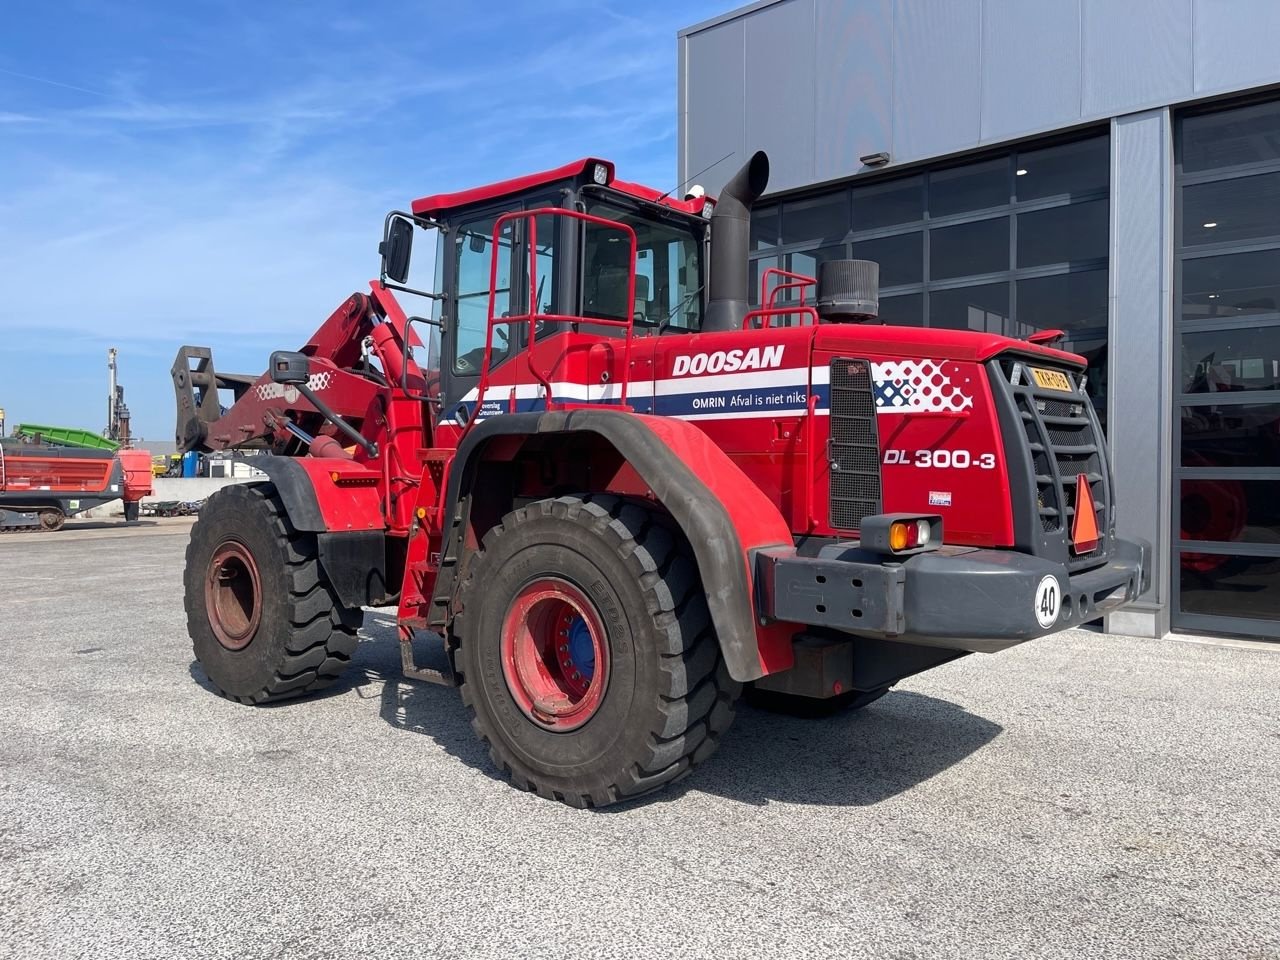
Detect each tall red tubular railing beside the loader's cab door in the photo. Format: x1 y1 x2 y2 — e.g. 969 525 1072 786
460 207 636 439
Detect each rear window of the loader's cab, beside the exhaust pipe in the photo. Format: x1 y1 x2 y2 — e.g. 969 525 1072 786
582 201 703 332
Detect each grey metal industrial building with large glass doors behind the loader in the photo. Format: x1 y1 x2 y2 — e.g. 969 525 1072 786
678 0 1280 647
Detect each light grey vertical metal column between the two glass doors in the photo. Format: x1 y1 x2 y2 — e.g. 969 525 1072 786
1107 109 1172 636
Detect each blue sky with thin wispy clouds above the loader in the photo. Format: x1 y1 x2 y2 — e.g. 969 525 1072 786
0 0 735 442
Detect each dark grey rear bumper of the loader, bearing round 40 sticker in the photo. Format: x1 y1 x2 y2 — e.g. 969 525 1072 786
756 540 1151 653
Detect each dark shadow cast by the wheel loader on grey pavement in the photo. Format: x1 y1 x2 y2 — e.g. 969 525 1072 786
207 613 1002 810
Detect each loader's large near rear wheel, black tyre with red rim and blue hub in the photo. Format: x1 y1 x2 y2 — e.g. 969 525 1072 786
449 495 741 806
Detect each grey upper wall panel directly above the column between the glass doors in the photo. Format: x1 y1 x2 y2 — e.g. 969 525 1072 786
1082 0 1192 116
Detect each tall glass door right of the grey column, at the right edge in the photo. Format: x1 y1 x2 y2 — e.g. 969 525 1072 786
1172 101 1280 636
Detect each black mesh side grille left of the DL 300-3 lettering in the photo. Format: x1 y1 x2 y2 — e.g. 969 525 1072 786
827 357 882 530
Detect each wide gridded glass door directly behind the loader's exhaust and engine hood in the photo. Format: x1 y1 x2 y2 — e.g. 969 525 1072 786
751 134 1111 419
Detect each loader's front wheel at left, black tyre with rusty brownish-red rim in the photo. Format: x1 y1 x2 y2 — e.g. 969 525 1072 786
184 484 364 704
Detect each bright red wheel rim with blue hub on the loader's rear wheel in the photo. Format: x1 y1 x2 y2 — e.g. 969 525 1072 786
502 577 609 732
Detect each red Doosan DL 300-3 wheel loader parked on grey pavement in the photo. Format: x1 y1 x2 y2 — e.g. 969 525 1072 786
173 154 1151 806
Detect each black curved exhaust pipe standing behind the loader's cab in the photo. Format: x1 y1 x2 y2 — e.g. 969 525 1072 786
703 150 769 330
